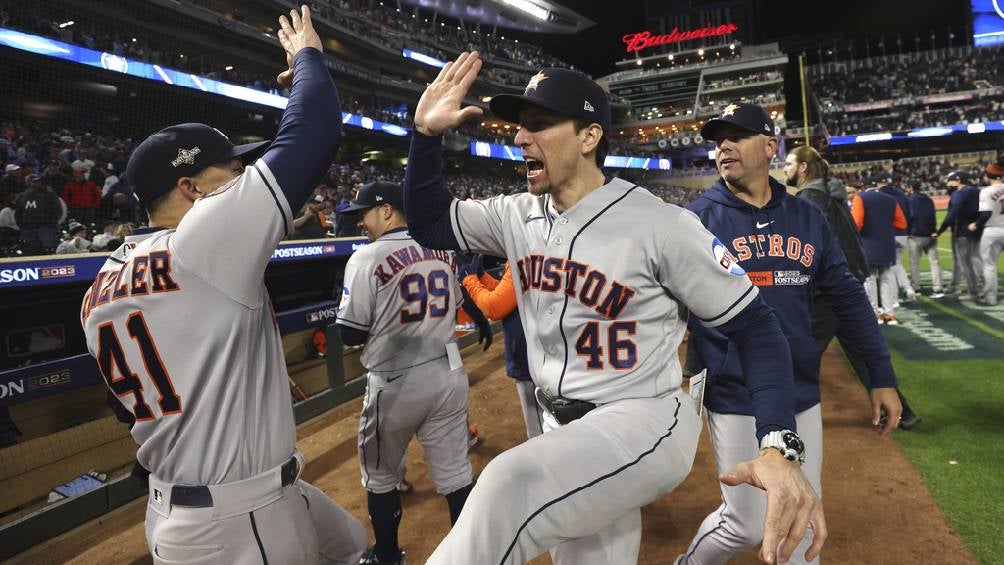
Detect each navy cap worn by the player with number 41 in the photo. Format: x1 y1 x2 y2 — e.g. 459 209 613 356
126 123 270 206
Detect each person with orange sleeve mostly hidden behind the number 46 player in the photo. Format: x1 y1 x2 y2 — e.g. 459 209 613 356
461 255 543 439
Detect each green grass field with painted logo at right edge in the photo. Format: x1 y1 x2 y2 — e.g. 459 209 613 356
859 212 1004 563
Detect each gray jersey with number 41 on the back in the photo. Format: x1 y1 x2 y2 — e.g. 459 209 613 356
80 160 296 485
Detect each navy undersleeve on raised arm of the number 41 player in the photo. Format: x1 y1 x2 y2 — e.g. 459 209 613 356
262 48 341 214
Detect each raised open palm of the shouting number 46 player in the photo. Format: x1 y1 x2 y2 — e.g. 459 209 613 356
415 51 485 135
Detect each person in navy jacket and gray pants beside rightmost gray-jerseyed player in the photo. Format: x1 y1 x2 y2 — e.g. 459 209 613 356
935 170 983 299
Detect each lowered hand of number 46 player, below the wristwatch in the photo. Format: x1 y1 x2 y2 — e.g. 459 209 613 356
718 449 826 563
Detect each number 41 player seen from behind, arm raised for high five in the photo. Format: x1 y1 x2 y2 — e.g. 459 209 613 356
81 7 366 564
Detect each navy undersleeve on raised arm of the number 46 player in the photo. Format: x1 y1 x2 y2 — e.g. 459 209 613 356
405 130 460 250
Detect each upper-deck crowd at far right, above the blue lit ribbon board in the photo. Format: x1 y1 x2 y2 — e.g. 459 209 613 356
809 46 1004 135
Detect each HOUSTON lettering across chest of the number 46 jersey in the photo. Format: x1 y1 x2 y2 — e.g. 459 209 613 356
516 255 636 320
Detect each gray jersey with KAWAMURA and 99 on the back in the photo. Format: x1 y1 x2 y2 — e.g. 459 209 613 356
337 228 463 372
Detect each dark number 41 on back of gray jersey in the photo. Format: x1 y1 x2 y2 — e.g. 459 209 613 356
97 311 182 421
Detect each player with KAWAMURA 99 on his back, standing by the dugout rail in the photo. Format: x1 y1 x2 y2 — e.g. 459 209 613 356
337 182 473 565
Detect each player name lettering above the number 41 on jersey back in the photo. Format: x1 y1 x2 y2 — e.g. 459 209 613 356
80 249 182 320
